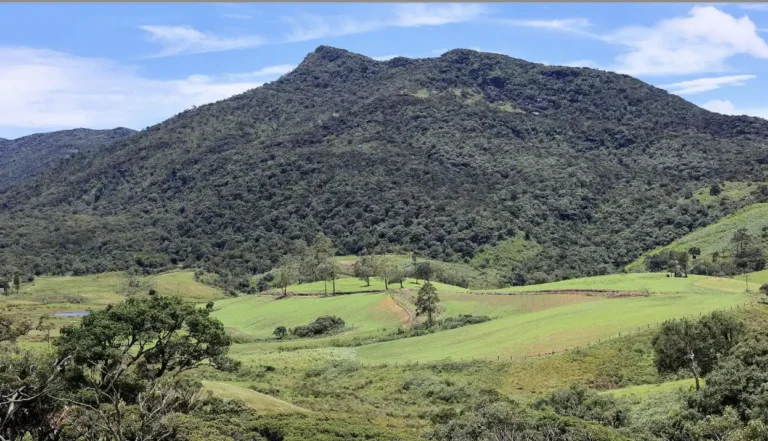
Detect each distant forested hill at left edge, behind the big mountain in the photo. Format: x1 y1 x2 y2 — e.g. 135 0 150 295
0 127 136 191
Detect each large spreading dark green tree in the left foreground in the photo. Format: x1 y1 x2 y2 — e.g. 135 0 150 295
55 296 238 441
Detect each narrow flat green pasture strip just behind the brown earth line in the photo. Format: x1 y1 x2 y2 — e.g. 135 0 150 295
494 273 759 294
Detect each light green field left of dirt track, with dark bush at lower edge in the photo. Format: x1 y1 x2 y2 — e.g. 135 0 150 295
213 293 408 337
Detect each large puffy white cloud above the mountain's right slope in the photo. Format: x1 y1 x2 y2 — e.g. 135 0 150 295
602 6 768 75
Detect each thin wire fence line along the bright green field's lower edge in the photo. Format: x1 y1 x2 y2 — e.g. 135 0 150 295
358 299 756 367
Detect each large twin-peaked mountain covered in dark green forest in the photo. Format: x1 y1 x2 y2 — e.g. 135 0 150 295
0 46 768 279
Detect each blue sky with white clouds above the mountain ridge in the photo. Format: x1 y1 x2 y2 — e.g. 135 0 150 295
0 3 768 139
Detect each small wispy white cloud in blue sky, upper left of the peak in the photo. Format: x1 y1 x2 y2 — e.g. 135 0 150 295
139 25 266 57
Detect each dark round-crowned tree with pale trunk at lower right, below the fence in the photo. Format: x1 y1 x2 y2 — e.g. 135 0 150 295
651 312 743 390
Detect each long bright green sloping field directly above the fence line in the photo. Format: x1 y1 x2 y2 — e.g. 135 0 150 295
356 293 748 363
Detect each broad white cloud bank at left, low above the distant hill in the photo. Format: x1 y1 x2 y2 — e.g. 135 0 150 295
0 47 284 136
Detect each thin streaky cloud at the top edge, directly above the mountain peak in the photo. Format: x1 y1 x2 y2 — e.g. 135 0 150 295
284 3 485 42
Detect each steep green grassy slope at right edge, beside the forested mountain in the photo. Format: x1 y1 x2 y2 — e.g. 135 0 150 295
626 203 768 271
